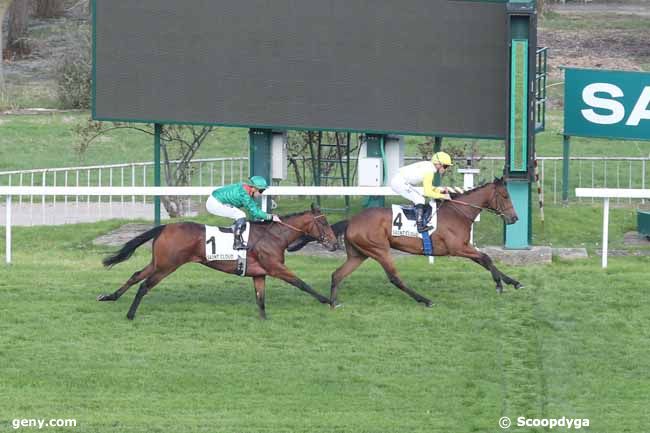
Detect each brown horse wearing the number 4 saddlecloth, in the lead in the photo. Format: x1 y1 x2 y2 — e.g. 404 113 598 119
289 179 523 307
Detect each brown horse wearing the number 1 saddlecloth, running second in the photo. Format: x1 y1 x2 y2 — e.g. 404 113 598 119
97 205 338 320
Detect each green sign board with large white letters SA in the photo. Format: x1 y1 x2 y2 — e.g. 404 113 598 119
564 69 650 140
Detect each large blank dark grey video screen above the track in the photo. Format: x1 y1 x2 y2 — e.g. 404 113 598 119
93 0 508 138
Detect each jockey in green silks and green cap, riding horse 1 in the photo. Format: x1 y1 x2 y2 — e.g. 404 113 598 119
205 176 280 250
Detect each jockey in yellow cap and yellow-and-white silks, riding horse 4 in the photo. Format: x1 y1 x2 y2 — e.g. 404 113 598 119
390 152 454 232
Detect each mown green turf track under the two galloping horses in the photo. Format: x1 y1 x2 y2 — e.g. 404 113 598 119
0 216 650 433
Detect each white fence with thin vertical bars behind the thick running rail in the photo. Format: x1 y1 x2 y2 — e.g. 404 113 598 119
0 156 650 225
